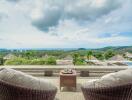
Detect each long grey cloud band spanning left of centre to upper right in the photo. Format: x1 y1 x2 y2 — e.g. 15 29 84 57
31 0 121 31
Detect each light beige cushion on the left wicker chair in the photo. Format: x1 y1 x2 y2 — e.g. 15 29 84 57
0 68 56 90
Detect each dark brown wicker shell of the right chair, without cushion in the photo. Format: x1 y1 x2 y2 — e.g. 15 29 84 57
81 83 132 100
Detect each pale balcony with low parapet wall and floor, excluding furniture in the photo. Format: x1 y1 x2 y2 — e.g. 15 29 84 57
1 65 128 100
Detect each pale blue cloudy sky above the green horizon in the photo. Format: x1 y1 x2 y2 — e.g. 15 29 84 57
0 0 132 49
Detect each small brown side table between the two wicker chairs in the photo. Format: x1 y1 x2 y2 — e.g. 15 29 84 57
60 70 77 90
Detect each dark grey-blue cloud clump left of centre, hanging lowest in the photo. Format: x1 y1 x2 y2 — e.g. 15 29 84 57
32 4 61 31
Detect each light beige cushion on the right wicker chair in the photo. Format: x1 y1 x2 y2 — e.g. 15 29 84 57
83 69 132 88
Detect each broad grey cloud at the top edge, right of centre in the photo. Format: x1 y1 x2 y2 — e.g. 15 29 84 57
65 0 120 21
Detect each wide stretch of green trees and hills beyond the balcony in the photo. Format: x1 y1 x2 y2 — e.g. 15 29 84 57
0 46 132 65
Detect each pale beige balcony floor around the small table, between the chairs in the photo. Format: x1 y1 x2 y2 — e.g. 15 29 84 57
40 77 98 100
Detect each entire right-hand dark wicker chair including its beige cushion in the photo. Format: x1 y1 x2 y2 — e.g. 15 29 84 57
81 69 132 100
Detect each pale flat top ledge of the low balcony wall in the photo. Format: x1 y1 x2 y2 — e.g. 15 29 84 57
0 65 129 71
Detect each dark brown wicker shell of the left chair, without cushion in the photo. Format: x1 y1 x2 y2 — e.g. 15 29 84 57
0 68 57 100
